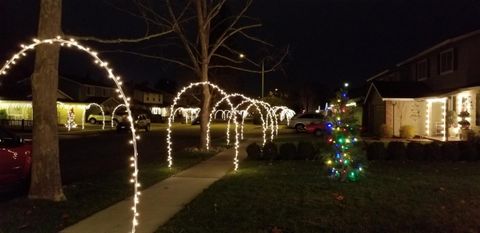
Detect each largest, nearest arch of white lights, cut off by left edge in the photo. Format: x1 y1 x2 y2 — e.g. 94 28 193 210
0 36 140 233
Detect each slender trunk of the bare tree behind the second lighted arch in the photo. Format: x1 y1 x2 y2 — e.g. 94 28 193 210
195 0 211 150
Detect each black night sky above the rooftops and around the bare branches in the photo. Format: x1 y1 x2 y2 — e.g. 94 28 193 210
0 0 480 98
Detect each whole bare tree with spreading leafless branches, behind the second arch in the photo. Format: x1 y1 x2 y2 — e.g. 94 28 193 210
71 0 286 149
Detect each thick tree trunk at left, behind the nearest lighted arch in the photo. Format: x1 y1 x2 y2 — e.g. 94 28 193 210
29 0 65 201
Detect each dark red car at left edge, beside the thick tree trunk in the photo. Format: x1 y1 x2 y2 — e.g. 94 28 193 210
0 128 32 190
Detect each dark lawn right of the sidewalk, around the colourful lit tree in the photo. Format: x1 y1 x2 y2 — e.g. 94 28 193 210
157 161 480 233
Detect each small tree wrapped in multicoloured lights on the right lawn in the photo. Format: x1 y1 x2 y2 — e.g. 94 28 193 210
326 83 362 181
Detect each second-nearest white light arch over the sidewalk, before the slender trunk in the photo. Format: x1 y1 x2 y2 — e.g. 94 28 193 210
167 81 239 170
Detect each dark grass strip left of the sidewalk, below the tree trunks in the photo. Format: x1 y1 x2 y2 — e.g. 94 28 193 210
0 152 212 233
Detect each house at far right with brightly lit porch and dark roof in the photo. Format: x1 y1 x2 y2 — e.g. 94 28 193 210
363 30 480 140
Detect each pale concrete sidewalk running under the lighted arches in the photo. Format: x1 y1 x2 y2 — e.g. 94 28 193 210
61 141 251 233
